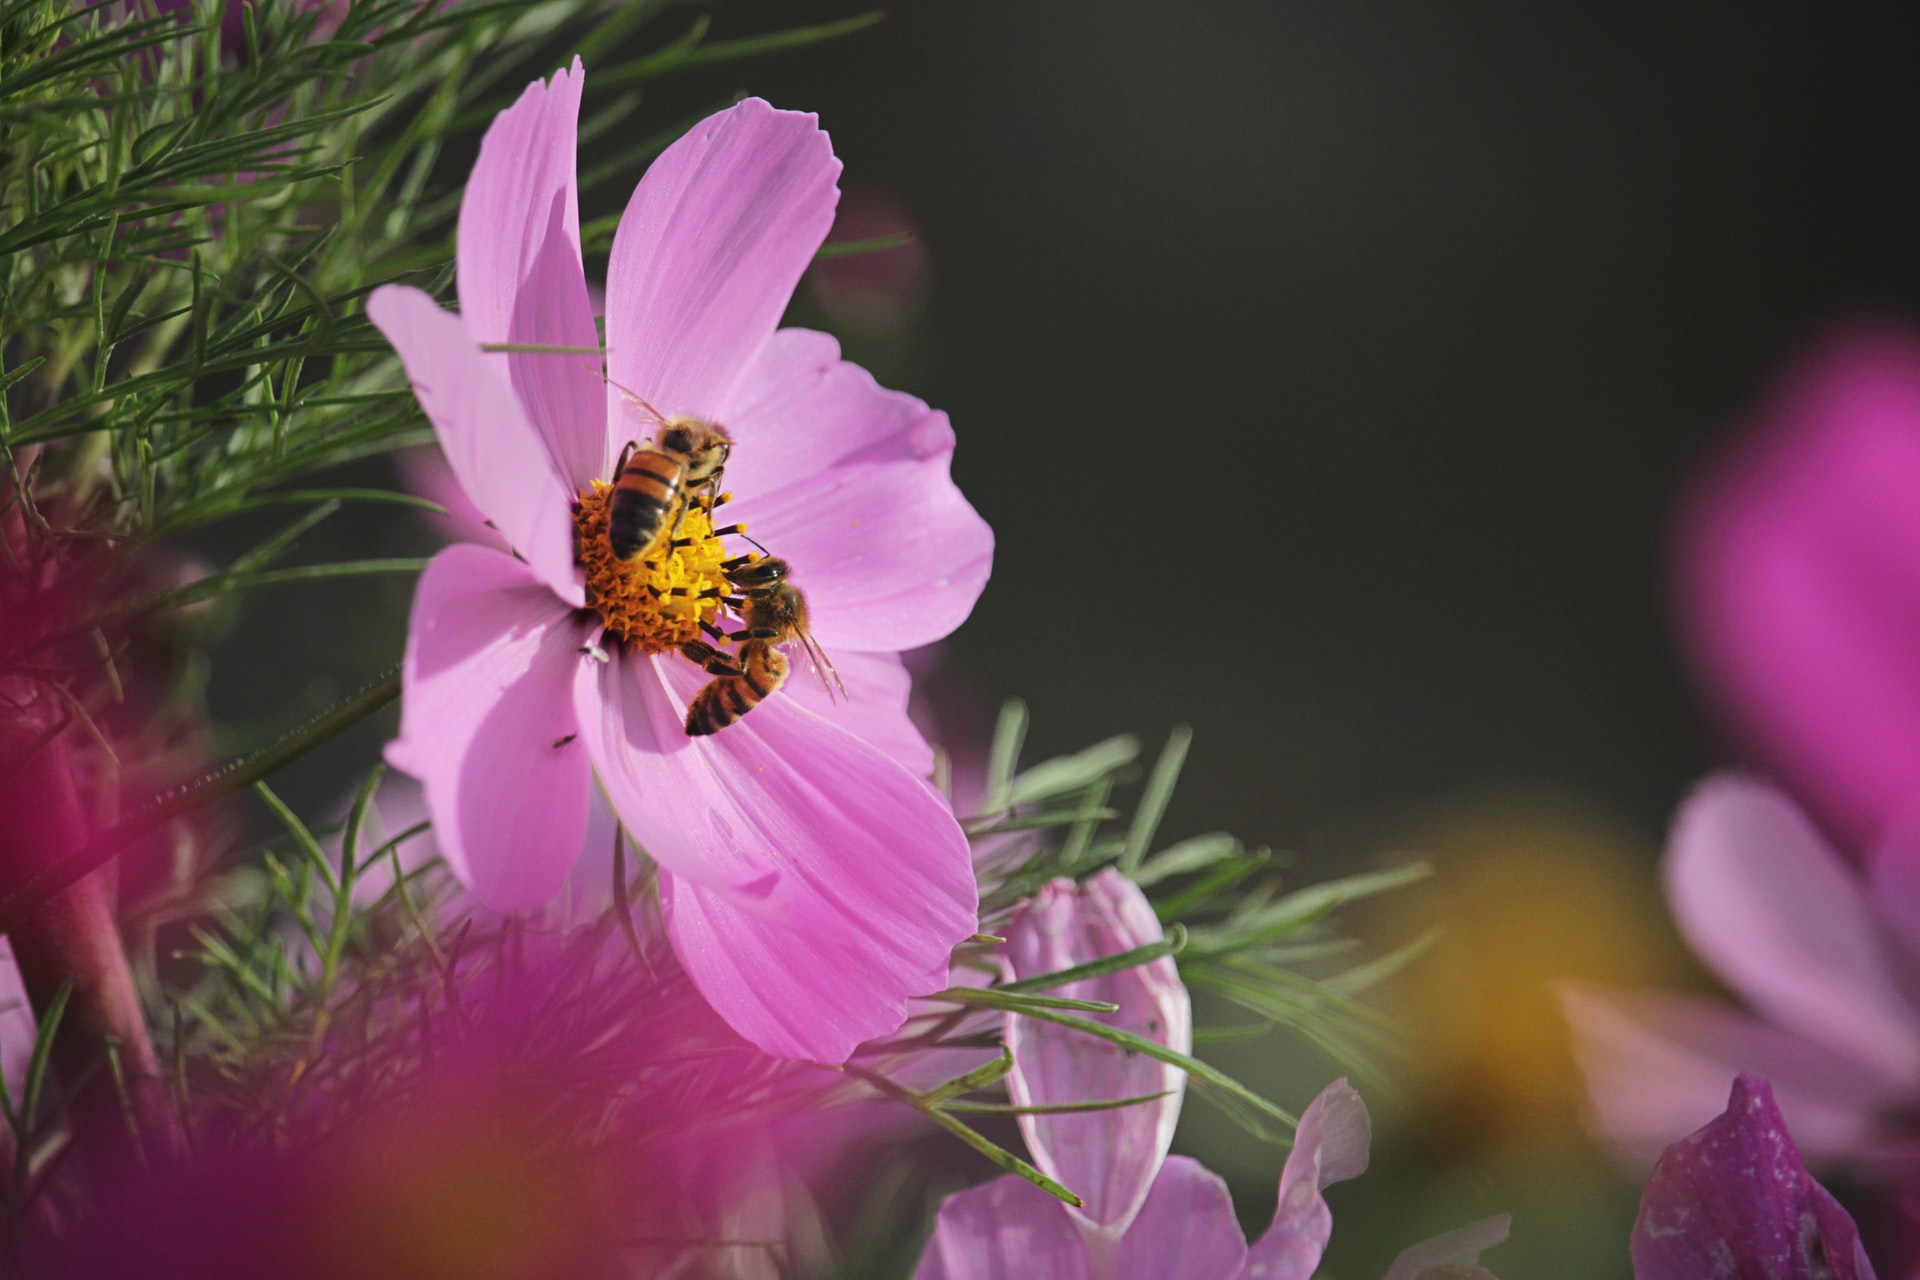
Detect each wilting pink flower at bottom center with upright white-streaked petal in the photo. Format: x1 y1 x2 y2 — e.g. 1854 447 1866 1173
914 869 1507 1280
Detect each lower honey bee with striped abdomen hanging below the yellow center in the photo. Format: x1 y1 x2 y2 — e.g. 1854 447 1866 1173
682 557 847 737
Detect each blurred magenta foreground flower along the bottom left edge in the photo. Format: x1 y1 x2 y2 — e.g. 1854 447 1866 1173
33 925 841 1280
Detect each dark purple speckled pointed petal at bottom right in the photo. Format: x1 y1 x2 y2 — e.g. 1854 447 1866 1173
1630 1075 1874 1280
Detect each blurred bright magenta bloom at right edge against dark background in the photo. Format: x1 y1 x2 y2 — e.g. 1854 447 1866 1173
1674 320 1920 852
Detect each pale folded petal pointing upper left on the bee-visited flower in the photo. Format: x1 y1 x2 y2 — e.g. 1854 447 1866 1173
367 284 586 606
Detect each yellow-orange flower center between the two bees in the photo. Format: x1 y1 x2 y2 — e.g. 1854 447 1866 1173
574 480 733 652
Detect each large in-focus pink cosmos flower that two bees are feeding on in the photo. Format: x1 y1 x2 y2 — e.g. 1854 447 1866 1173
367 61 993 1061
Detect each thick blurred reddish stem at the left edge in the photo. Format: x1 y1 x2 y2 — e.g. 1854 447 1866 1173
0 714 179 1155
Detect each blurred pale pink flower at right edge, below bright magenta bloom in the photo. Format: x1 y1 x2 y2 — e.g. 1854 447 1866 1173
1563 775 1920 1182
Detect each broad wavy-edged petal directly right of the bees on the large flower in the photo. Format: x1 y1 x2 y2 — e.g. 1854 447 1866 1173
728 330 993 651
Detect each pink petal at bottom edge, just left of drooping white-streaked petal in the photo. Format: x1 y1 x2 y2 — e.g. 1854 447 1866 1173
914 1176 1098 1280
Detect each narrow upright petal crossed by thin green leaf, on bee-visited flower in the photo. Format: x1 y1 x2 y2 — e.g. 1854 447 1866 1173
455 58 612 491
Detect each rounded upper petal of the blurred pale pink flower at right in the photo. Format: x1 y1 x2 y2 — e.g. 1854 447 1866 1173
1665 775 1920 1079
